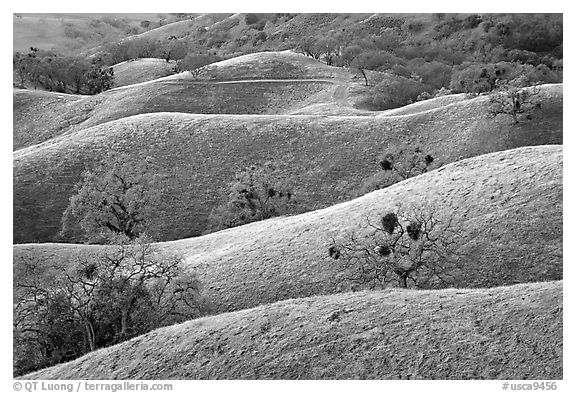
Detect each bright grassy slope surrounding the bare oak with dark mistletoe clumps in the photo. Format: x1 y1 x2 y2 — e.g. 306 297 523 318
14 146 562 312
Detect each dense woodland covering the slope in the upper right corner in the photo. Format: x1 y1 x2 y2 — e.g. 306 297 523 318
295 14 562 110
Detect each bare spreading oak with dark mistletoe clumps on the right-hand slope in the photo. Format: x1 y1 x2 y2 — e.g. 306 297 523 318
328 207 462 289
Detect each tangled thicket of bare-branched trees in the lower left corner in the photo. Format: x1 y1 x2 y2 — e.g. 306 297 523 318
13 236 206 375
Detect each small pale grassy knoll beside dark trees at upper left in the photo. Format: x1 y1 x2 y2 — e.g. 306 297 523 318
113 59 175 87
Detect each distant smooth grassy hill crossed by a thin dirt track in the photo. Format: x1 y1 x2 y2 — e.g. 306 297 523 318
14 53 351 148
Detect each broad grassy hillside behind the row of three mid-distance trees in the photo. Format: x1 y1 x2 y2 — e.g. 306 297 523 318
14 83 562 243
